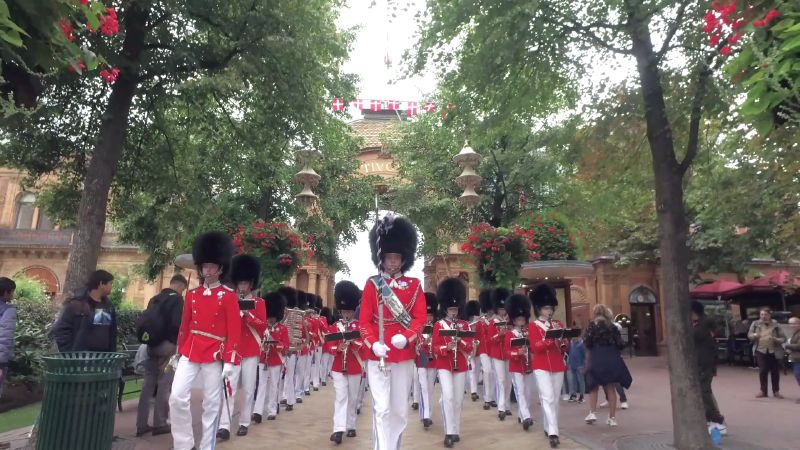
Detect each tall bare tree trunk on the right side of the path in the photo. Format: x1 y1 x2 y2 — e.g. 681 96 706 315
627 5 714 450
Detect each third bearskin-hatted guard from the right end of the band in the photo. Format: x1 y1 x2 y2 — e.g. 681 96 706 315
487 287 511 421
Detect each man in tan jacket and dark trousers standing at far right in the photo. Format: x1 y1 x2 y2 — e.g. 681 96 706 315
747 308 786 398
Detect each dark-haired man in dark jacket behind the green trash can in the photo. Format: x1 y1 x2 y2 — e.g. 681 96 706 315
51 270 117 352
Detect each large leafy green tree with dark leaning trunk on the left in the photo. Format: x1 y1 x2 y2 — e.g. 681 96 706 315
2 0 364 292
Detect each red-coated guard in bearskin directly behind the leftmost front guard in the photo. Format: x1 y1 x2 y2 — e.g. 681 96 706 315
217 254 267 441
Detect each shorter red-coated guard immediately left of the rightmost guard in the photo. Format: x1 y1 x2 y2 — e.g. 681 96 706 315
506 294 536 431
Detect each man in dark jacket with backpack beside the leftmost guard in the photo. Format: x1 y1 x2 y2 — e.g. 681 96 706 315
136 275 188 437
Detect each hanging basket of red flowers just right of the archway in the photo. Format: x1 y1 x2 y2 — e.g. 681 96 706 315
461 223 540 289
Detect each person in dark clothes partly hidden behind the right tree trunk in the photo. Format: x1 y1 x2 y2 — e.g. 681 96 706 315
692 300 728 435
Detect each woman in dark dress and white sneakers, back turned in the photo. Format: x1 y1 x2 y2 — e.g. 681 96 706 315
584 305 633 427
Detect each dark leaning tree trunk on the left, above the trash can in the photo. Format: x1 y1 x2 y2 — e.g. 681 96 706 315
64 2 150 296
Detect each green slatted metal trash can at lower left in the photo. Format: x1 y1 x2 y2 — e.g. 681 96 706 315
36 352 128 450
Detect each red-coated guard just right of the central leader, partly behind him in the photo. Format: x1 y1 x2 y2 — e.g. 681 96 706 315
411 292 438 429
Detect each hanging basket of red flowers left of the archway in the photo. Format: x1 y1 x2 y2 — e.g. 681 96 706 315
233 220 314 293
